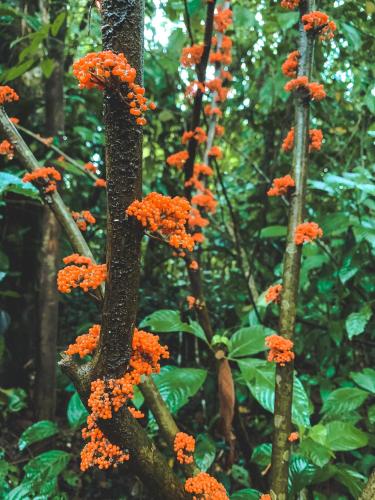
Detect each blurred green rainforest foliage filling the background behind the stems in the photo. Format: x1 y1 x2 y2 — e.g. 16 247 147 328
0 0 375 500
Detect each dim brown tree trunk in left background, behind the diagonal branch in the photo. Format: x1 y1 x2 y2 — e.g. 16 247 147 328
35 0 66 420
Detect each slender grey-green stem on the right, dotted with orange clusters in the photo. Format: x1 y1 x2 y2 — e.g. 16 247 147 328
271 0 314 500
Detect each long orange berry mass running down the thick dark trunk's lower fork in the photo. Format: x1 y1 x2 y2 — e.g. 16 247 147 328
81 329 169 471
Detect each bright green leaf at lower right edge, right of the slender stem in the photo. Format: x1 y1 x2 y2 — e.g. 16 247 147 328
326 420 368 451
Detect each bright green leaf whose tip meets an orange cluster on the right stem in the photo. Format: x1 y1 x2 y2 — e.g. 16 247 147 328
229 325 275 358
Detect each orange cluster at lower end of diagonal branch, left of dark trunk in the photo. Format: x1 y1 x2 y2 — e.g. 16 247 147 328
57 254 107 293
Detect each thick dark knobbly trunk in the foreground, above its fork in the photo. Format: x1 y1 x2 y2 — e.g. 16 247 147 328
97 0 144 377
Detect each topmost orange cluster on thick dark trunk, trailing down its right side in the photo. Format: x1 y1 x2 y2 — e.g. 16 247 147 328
73 50 156 125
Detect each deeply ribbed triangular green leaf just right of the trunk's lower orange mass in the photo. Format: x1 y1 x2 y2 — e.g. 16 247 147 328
153 365 207 413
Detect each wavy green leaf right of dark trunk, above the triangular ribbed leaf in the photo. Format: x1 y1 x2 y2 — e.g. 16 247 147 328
140 309 207 342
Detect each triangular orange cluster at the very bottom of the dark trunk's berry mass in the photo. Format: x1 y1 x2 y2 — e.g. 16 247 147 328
81 416 130 472
